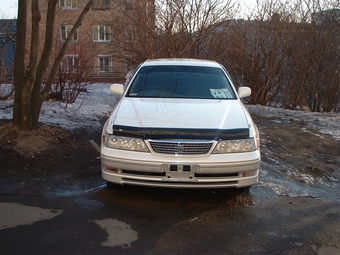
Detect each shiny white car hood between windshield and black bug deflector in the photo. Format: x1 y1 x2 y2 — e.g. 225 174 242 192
109 98 249 133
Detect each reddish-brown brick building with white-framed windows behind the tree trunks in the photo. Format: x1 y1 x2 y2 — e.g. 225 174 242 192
27 0 154 82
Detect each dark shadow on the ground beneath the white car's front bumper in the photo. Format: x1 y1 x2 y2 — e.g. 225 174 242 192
92 185 254 211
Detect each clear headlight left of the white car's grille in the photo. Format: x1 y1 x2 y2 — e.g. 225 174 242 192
104 134 149 152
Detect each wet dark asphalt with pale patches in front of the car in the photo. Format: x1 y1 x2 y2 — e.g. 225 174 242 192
0 164 340 255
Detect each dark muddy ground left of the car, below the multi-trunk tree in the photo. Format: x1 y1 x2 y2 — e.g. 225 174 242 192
0 120 100 194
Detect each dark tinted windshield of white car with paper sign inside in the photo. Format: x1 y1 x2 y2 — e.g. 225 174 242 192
127 66 236 99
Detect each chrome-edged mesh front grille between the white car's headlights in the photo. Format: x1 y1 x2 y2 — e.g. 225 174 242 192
150 141 212 155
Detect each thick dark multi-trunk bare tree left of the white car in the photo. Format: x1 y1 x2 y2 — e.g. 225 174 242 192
13 0 93 130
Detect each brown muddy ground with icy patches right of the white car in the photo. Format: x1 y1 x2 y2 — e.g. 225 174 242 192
253 115 340 179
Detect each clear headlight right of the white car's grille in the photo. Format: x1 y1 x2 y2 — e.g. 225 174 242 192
213 138 257 154
